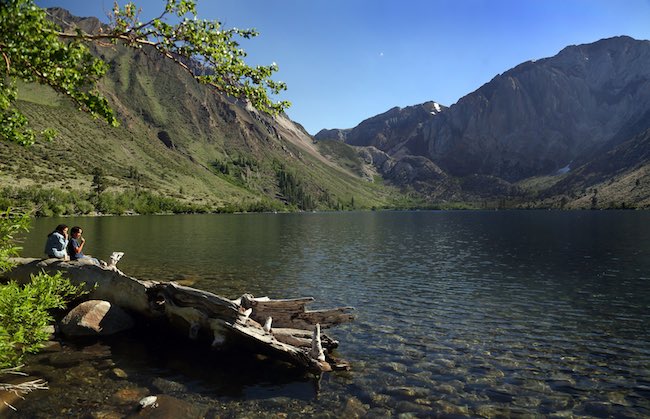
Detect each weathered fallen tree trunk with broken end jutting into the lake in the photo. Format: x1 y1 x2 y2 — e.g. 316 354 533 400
5 258 353 372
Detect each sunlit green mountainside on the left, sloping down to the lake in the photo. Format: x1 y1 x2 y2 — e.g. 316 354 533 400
0 8 396 214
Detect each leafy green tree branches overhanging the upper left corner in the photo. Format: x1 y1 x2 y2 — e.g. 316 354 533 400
0 0 290 144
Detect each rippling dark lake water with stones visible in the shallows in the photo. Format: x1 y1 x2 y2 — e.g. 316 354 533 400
8 211 650 418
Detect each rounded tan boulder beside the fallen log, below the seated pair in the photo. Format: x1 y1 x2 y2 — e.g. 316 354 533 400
60 300 133 336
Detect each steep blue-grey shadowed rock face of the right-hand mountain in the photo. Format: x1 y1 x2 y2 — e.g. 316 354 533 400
422 37 650 181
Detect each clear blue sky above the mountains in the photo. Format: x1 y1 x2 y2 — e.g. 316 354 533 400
36 0 650 134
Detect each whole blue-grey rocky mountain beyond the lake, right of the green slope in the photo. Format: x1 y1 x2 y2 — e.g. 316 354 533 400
316 36 650 207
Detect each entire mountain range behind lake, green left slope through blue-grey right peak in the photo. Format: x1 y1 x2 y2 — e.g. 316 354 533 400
6 9 650 215
